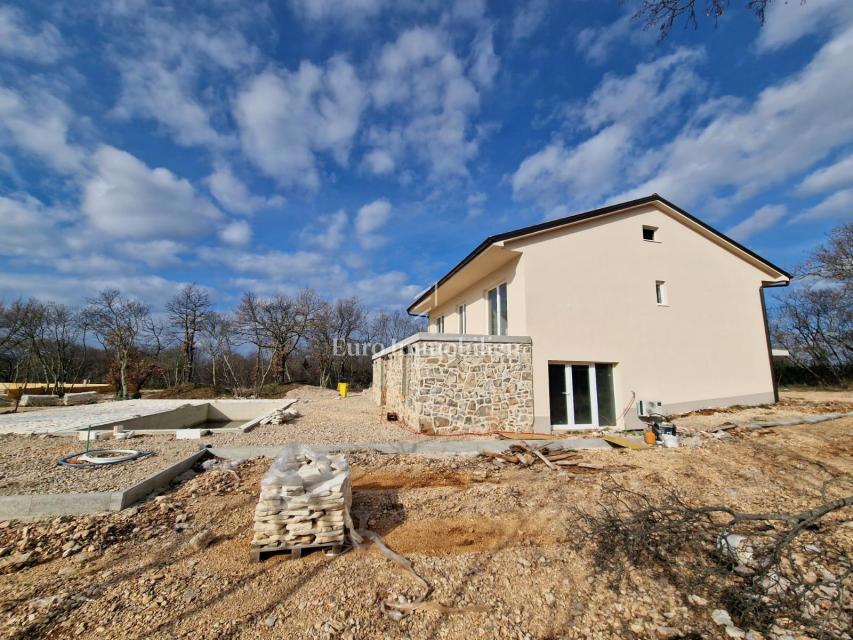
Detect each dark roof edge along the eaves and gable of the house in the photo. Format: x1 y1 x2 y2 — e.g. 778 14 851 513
407 193 791 313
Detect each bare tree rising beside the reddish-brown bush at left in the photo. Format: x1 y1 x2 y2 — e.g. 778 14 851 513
84 289 150 398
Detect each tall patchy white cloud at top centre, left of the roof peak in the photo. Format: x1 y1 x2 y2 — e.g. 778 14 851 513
368 28 486 180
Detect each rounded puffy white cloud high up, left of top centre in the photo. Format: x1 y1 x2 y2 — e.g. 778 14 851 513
234 57 366 189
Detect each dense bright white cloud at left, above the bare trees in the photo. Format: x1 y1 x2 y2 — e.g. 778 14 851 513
81 145 221 239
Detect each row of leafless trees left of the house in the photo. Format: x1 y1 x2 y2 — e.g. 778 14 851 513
0 284 424 398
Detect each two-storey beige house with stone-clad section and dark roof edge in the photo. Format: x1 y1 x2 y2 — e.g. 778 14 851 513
373 194 790 433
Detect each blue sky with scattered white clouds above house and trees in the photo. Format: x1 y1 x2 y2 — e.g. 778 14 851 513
0 0 853 308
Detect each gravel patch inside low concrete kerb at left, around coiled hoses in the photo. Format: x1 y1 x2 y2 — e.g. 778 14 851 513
0 435 199 495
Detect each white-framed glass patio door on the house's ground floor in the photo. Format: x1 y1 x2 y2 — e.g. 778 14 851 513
548 363 616 429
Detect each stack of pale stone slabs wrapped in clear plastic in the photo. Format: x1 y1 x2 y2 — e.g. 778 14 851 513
252 445 352 549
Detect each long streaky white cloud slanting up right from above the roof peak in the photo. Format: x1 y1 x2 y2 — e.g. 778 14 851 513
615 28 853 208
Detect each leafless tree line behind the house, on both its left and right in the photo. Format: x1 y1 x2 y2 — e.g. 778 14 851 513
0 222 853 398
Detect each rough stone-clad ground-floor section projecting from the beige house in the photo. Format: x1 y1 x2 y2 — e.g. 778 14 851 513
373 336 533 433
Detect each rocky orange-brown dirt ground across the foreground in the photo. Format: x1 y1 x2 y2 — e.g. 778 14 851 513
0 418 853 639
